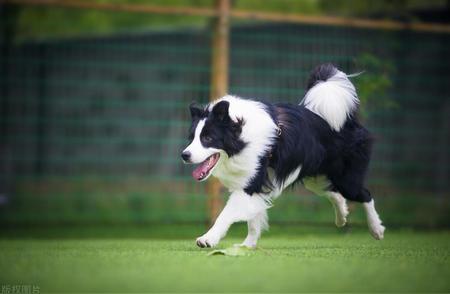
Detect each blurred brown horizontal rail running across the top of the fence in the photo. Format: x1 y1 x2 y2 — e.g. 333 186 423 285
0 0 450 34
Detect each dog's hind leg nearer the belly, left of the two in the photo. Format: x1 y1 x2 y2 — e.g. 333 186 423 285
303 176 349 227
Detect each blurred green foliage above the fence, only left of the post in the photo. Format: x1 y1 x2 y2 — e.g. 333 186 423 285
10 0 212 40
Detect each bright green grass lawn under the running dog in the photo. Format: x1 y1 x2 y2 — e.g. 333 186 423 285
0 225 450 292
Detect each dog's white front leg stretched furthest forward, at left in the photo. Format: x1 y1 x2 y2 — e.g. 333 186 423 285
197 191 269 247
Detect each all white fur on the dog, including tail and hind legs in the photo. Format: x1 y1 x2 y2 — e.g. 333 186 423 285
193 95 384 247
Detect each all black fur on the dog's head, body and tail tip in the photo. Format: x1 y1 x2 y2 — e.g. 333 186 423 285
186 64 373 202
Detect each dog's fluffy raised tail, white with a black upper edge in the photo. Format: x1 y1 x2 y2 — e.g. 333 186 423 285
300 63 359 131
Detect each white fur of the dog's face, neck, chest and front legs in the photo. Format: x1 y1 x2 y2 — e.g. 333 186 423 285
184 95 280 247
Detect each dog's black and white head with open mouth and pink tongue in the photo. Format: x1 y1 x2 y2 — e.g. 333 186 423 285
181 100 245 181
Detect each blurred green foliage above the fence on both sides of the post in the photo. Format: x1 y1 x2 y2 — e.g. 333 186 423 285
3 0 447 40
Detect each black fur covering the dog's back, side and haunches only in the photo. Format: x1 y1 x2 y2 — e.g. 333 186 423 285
246 103 372 202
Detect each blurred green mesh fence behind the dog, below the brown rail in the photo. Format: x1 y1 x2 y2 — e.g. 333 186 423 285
0 24 450 226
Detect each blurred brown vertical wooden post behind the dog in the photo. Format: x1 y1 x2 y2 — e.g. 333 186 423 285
207 0 230 223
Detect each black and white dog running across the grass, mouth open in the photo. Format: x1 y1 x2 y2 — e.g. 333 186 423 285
181 64 385 247
